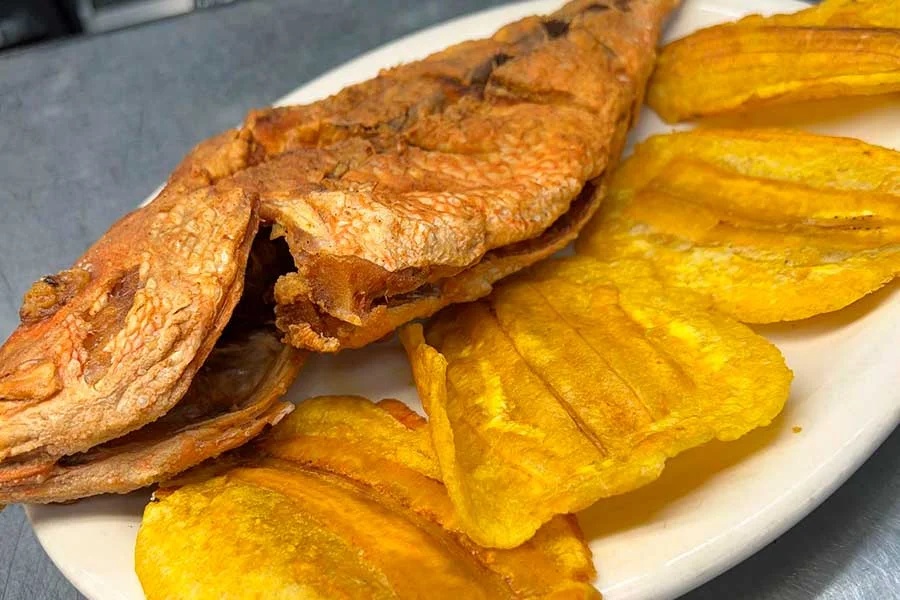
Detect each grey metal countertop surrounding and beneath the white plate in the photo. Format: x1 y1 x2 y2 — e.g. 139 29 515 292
0 0 900 600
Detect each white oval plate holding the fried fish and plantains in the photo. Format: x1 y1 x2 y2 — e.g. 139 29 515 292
28 0 900 600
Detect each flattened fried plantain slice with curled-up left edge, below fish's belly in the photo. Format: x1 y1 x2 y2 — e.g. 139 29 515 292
401 257 791 547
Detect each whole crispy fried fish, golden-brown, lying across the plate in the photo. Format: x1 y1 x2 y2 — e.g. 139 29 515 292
0 0 678 501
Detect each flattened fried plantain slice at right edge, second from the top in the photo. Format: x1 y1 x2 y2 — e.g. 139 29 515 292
576 129 900 323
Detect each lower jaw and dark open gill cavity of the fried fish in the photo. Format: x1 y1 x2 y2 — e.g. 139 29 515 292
0 228 306 502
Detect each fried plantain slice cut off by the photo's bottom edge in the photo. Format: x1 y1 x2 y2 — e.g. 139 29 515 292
136 397 599 600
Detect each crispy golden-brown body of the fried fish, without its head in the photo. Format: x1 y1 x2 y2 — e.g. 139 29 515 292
165 0 677 352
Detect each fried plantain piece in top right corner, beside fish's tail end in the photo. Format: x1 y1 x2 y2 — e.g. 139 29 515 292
647 0 900 123
